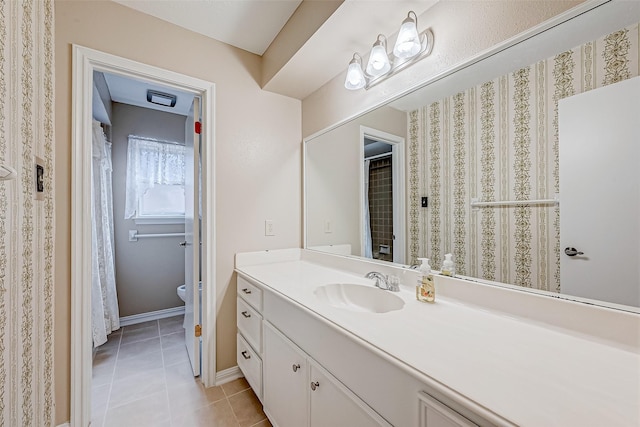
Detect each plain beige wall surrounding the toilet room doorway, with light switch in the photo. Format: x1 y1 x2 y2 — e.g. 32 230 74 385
55 0 301 424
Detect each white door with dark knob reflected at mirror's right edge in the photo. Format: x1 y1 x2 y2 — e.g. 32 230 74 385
559 77 640 306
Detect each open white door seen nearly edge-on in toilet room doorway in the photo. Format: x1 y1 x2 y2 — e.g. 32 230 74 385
184 98 201 376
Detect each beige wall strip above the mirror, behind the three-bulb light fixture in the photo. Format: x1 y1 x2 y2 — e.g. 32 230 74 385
302 0 583 137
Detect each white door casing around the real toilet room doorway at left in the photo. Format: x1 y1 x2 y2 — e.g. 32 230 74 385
71 46 216 426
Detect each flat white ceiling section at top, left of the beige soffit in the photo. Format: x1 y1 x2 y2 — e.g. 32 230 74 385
113 0 302 55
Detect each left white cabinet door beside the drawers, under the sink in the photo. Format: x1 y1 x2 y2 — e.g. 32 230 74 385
263 322 309 427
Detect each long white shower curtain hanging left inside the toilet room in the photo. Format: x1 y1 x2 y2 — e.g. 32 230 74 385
91 121 120 347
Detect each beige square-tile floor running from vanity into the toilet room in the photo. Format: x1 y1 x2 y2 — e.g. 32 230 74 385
91 316 271 427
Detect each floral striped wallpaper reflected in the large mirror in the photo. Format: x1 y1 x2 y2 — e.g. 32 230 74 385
408 24 640 292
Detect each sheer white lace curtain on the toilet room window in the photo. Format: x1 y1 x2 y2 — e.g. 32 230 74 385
124 135 185 219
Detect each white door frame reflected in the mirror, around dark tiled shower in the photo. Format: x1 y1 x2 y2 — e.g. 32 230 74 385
359 126 407 264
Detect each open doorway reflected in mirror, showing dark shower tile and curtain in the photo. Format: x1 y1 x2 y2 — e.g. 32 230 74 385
360 126 405 263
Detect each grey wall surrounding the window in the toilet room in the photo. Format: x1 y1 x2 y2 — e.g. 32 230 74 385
112 102 186 317
